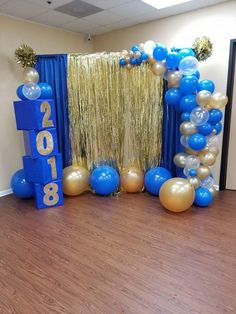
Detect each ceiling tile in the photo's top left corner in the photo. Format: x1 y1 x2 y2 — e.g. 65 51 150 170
0 0 47 19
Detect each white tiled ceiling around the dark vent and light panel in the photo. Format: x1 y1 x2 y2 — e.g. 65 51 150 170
0 0 232 35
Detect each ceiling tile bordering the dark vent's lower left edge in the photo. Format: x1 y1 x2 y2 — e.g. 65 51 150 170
31 10 75 26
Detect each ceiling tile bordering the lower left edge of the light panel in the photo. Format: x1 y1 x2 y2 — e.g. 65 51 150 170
109 0 156 17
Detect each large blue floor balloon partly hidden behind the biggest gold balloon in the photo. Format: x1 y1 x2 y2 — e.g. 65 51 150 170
144 167 172 195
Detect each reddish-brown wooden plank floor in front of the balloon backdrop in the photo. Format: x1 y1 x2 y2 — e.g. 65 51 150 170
0 191 236 314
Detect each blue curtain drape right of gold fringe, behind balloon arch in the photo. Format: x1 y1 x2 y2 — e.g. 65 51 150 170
161 82 183 176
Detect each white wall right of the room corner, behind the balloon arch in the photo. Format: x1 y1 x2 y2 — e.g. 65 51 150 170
94 1 236 183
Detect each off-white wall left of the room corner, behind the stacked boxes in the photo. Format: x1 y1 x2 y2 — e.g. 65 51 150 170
0 16 93 195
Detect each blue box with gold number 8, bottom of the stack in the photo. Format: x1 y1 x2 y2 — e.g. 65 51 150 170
34 180 64 209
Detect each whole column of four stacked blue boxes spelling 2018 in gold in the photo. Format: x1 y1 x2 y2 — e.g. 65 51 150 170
14 99 63 209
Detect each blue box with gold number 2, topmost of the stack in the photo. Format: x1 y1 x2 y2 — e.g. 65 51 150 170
14 99 56 130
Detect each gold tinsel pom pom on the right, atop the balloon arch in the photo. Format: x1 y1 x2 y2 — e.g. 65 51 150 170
192 36 213 62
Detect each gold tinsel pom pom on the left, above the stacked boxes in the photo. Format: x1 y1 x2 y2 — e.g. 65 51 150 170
15 44 36 68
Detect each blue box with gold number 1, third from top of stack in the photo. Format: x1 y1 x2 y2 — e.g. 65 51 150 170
23 154 63 184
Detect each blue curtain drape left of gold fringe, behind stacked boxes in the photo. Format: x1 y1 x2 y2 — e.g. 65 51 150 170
35 54 71 167
